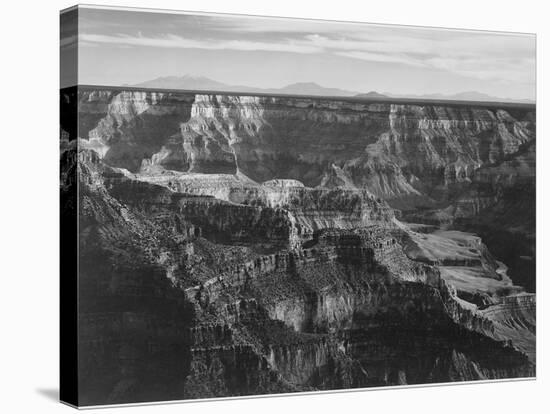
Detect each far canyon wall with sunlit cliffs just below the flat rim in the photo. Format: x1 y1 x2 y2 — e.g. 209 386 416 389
76 92 535 194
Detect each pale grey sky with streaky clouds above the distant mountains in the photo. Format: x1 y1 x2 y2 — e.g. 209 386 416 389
61 8 536 99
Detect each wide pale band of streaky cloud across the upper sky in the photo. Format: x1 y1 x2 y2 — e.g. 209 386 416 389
79 15 536 84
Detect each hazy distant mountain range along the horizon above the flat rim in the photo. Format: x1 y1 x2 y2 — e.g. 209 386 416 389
131 75 535 103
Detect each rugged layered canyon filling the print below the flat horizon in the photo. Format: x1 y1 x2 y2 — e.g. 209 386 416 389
60 87 536 405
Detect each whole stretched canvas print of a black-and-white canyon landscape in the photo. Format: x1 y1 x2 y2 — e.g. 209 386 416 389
60 6 536 407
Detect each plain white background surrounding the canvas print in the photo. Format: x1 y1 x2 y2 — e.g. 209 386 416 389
0 0 550 414
